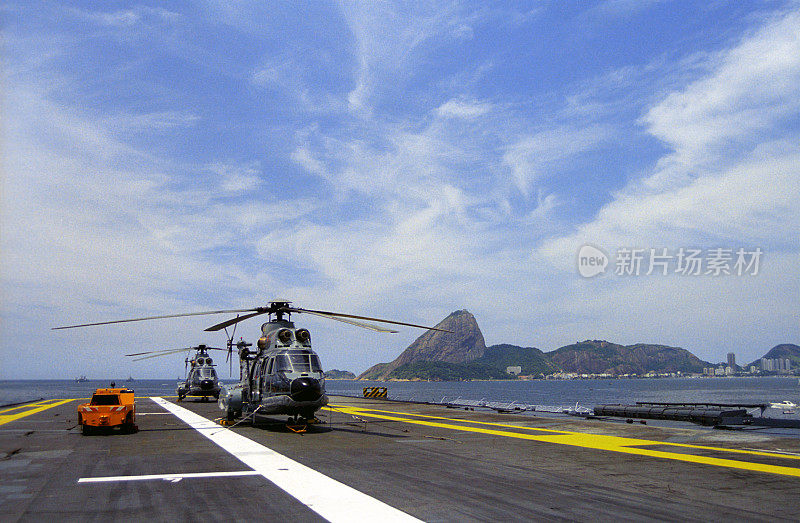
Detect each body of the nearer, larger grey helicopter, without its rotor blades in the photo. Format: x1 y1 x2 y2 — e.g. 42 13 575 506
219 319 328 423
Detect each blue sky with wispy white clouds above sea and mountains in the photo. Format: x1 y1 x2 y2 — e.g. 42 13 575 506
0 0 800 378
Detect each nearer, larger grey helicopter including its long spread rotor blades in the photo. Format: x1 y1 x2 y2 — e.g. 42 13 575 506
55 300 450 425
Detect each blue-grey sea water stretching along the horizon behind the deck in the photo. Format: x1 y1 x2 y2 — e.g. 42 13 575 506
0 377 800 412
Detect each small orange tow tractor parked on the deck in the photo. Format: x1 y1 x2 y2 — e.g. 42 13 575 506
78 389 139 435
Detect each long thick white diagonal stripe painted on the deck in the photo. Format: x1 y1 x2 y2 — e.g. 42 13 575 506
150 397 420 523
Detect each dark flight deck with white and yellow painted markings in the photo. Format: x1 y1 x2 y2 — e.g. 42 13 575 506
0 397 800 521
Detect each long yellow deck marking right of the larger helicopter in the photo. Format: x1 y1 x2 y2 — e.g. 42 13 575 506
332 405 800 477
